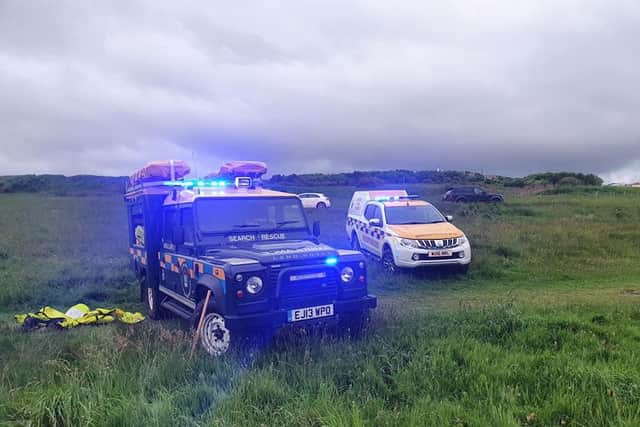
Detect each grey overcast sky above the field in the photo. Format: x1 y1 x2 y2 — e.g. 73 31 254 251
0 0 640 181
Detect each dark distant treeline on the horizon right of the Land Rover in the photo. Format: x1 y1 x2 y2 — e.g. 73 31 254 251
269 169 603 187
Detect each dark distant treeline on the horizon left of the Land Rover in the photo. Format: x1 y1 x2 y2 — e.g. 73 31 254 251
0 175 127 196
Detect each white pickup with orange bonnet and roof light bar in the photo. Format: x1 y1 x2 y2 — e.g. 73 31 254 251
346 190 471 272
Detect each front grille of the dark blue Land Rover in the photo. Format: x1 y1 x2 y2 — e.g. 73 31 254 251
269 266 339 309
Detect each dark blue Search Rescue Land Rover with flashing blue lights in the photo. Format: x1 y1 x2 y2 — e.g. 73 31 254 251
125 161 376 355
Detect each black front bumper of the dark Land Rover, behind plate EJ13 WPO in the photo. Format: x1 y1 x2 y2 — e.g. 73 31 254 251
224 295 378 332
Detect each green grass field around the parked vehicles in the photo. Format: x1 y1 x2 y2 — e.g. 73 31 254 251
0 186 640 426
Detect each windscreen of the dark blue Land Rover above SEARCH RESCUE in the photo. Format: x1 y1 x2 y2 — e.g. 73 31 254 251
196 197 307 233
